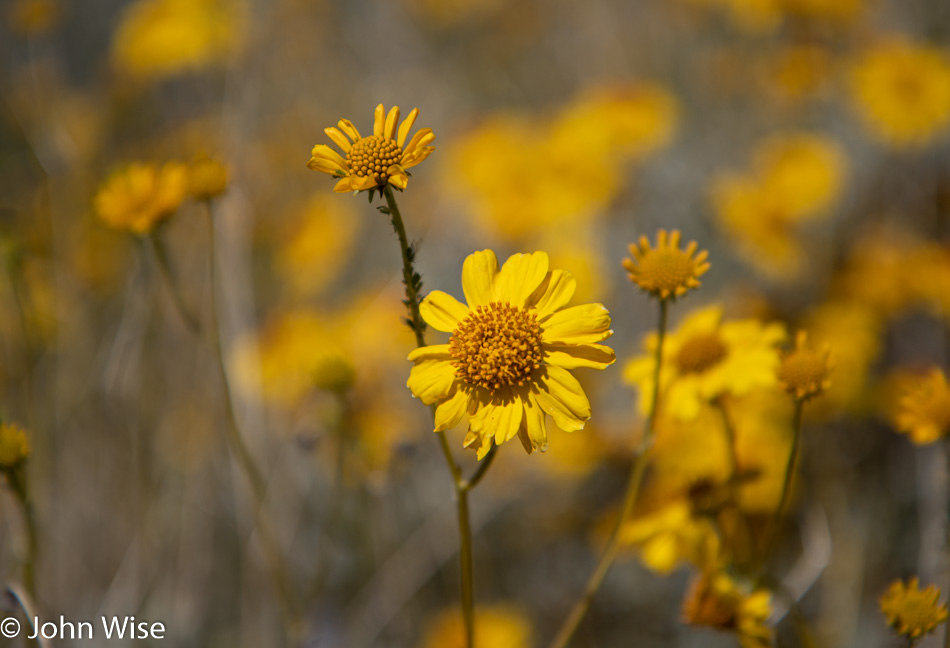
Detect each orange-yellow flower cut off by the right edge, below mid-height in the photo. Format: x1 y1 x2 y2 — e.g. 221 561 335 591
894 367 950 445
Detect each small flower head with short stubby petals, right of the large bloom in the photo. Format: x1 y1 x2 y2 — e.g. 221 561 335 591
623 229 709 299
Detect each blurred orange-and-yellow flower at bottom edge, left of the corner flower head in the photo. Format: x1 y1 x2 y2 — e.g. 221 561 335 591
683 572 774 648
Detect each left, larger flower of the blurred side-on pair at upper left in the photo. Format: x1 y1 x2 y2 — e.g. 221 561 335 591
95 162 188 235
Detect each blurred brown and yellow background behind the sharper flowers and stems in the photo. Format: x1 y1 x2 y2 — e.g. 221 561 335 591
0 0 950 648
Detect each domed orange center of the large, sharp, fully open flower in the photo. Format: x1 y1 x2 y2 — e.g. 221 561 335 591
449 302 541 393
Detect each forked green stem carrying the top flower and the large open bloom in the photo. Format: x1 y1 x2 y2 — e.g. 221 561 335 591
383 185 484 648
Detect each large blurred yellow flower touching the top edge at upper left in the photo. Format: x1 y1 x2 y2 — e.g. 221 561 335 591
112 0 247 80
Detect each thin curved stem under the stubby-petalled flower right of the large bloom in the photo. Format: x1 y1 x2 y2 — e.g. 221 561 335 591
551 299 668 648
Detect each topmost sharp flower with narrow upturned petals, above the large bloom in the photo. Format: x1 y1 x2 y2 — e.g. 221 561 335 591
307 104 435 193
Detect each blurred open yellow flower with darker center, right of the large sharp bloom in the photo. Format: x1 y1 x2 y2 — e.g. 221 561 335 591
623 306 785 420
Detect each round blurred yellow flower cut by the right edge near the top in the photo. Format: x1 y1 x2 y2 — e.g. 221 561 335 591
851 38 950 148
